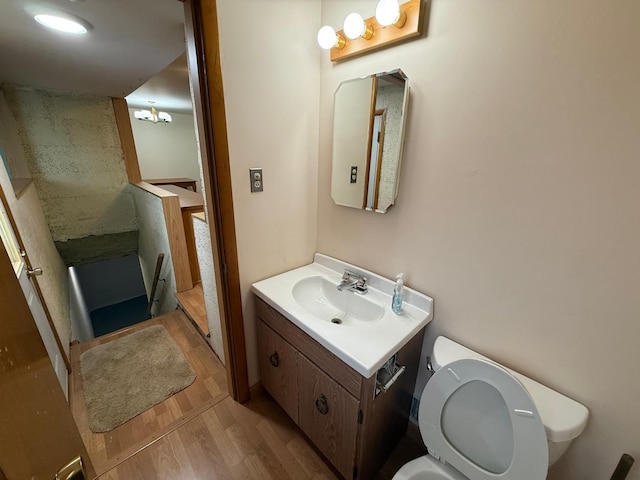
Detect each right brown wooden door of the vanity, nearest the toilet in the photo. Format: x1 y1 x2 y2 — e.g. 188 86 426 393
298 355 360 478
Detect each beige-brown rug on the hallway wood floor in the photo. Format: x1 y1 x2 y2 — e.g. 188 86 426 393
80 325 196 433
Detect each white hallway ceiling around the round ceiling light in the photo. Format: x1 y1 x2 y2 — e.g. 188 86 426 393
0 0 191 112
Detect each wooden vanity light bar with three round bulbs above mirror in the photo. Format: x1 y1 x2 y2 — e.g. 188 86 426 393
318 0 429 62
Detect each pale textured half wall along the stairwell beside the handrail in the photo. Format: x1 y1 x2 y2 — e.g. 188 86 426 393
131 186 177 316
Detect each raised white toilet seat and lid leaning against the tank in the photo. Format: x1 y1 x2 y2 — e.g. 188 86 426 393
418 359 549 480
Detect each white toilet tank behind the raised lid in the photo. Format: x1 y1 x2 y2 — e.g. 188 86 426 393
432 337 589 466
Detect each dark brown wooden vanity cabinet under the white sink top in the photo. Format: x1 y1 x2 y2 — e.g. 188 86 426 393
255 297 424 480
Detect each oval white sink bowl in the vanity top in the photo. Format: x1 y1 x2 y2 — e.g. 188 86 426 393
292 275 384 325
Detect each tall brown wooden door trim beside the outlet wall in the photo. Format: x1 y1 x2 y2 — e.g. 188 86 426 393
184 0 250 402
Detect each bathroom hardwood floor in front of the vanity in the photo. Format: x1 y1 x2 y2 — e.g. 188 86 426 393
101 393 337 480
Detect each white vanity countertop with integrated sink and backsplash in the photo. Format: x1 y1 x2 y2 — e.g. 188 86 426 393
251 253 433 378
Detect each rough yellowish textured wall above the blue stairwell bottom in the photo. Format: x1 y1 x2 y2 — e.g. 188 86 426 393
5 86 137 242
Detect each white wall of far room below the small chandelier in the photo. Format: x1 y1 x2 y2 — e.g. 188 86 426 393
129 108 202 192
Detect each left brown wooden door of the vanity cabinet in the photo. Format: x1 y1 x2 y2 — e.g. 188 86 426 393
258 320 298 423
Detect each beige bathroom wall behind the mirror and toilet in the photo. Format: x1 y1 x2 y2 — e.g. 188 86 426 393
316 0 640 480
